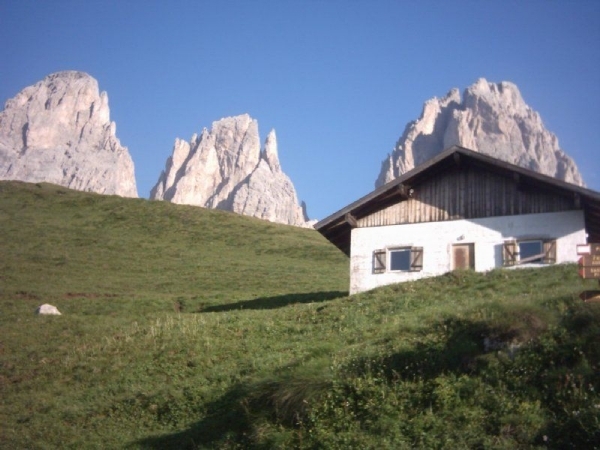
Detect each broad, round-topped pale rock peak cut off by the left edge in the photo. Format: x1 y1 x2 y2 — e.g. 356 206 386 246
0 71 138 197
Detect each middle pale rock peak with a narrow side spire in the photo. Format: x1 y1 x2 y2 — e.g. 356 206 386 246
150 114 309 226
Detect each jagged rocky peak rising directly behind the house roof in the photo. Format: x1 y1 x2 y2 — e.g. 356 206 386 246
375 78 583 187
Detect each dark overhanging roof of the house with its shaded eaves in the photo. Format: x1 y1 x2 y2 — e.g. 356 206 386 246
315 146 600 256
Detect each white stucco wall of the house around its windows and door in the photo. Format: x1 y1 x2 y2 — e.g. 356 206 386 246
350 211 587 294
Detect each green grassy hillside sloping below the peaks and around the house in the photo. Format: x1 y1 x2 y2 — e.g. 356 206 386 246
0 182 600 449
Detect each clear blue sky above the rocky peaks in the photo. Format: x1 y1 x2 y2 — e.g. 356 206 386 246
0 0 600 219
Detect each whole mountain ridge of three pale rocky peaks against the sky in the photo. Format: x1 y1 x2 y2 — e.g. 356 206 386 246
0 71 584 227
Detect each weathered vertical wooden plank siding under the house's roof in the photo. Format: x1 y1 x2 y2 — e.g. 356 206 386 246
357 166 580 227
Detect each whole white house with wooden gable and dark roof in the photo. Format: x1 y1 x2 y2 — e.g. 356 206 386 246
315 146 600 294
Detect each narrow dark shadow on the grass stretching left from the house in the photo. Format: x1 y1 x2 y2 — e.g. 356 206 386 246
199 291 348 313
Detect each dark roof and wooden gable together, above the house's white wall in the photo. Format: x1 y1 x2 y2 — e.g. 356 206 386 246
315 146 600 255
